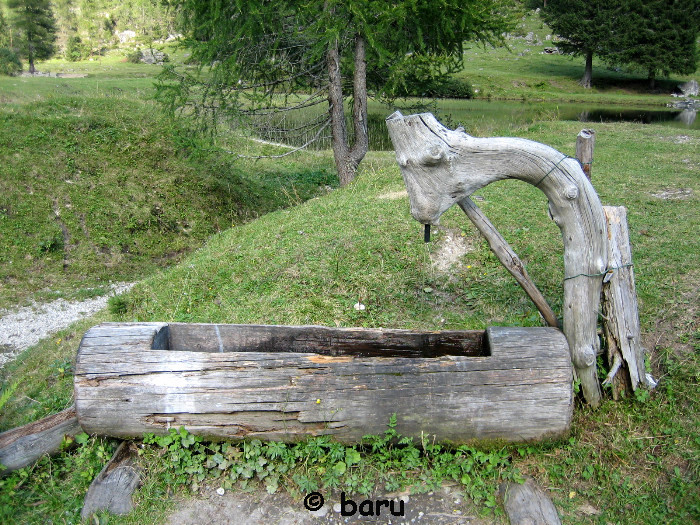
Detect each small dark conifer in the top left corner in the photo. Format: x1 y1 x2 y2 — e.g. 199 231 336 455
7 0 56 73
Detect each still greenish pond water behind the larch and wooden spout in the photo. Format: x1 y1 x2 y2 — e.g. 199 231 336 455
254 100 700 151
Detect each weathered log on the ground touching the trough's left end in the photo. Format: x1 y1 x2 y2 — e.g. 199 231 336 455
0 407 83 475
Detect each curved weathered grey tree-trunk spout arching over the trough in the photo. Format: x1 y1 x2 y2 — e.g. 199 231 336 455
386 111 607 406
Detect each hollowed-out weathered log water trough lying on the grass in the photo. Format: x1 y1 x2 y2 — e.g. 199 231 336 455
75 323 573 443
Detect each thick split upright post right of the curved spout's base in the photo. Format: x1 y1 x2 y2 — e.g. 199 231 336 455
602 206 646 399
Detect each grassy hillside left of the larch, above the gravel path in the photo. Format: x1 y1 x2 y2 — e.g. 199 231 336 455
0 64 335 309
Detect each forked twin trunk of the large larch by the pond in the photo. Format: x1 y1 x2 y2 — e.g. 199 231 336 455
326 35 369 186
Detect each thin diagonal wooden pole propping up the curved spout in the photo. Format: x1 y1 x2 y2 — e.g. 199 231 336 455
457 197 560 328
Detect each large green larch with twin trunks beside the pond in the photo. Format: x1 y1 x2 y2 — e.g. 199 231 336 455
159 0 513 185
